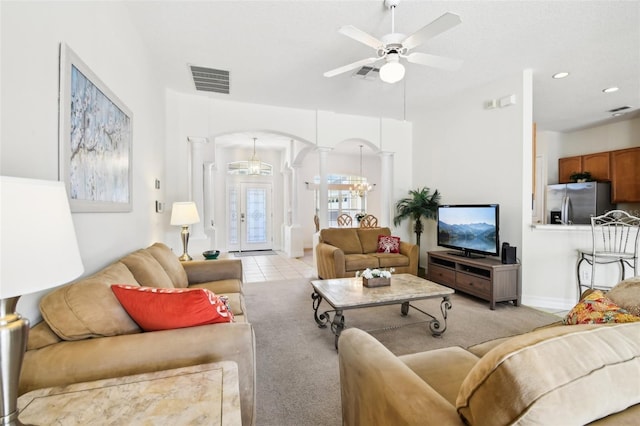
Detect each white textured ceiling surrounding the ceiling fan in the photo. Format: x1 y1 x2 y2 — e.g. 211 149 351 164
125 0 640 146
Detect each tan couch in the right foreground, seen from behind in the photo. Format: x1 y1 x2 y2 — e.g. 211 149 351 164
338 322 640 426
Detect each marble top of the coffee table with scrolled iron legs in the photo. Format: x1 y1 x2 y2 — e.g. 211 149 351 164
311 274 454 309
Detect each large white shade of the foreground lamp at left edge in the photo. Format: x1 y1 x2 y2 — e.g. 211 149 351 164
0 176 84 299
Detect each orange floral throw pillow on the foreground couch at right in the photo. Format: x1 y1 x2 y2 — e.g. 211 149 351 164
562 290 640 324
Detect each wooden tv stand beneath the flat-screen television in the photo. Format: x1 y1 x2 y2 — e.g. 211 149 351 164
427 251 521 310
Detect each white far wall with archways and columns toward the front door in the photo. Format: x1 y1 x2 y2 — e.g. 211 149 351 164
165 91 412 253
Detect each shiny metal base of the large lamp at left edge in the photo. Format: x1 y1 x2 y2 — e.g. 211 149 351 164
0 296 29 426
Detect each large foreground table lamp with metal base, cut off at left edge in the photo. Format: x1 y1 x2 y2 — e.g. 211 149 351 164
0 176 84 425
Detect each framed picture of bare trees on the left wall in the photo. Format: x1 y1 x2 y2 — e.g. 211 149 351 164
59 43 133 212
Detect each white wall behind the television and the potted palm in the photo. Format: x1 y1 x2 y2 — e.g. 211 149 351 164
406 71 532 270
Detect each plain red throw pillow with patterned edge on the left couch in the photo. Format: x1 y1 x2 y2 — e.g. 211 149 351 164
111 284 233 331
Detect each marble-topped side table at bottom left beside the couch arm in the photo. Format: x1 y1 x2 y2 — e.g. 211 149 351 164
18 361 242 426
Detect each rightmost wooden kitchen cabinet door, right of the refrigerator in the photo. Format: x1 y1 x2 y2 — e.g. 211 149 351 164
610 147 640 203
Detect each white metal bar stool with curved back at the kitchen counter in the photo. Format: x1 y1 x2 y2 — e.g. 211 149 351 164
576 210 640 298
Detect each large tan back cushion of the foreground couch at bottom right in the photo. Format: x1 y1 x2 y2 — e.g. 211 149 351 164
456 323 640 425
